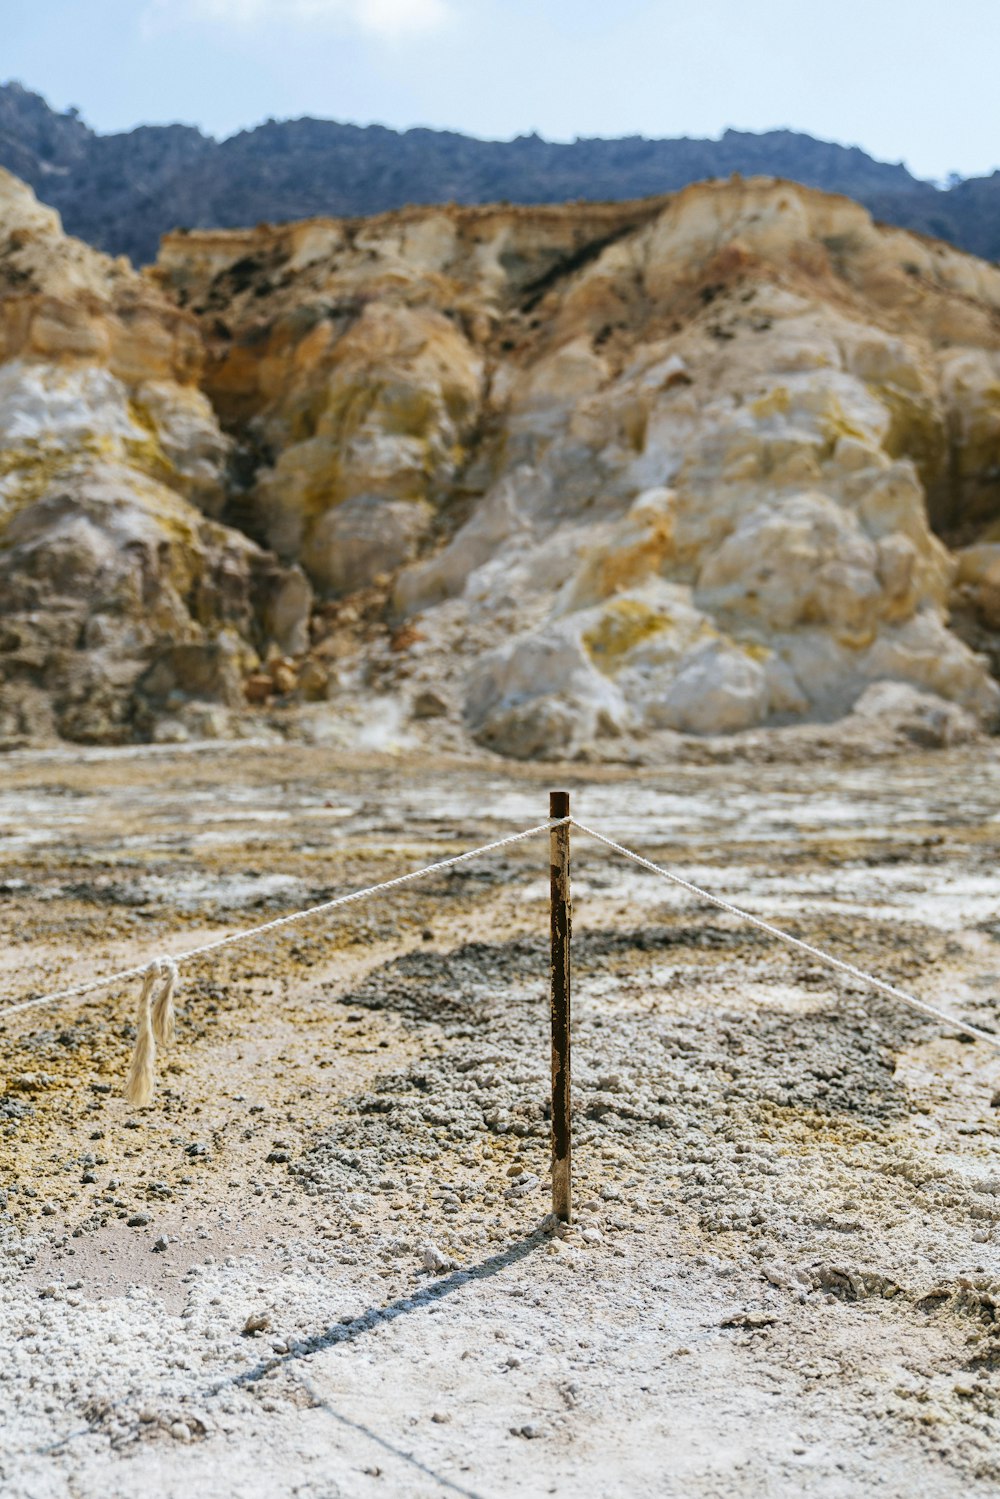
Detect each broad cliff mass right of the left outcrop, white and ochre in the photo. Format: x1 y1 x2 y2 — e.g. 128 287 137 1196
146 178 1000 757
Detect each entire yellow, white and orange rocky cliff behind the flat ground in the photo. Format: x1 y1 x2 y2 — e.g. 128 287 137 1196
0 178 1000 757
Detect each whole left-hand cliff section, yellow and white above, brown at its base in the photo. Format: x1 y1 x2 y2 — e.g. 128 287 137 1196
0 172 312 744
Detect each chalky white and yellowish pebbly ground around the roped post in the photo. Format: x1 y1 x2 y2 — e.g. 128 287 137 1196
0 745 1000 1499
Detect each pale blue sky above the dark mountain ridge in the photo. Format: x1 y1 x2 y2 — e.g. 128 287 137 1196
7 0 1000 178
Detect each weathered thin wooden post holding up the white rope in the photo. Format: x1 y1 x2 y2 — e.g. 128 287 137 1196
549 791 573 1223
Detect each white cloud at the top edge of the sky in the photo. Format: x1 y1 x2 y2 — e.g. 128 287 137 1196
142 0 451 40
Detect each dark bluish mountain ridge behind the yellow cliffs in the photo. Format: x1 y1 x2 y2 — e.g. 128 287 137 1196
0 82 1000 262
